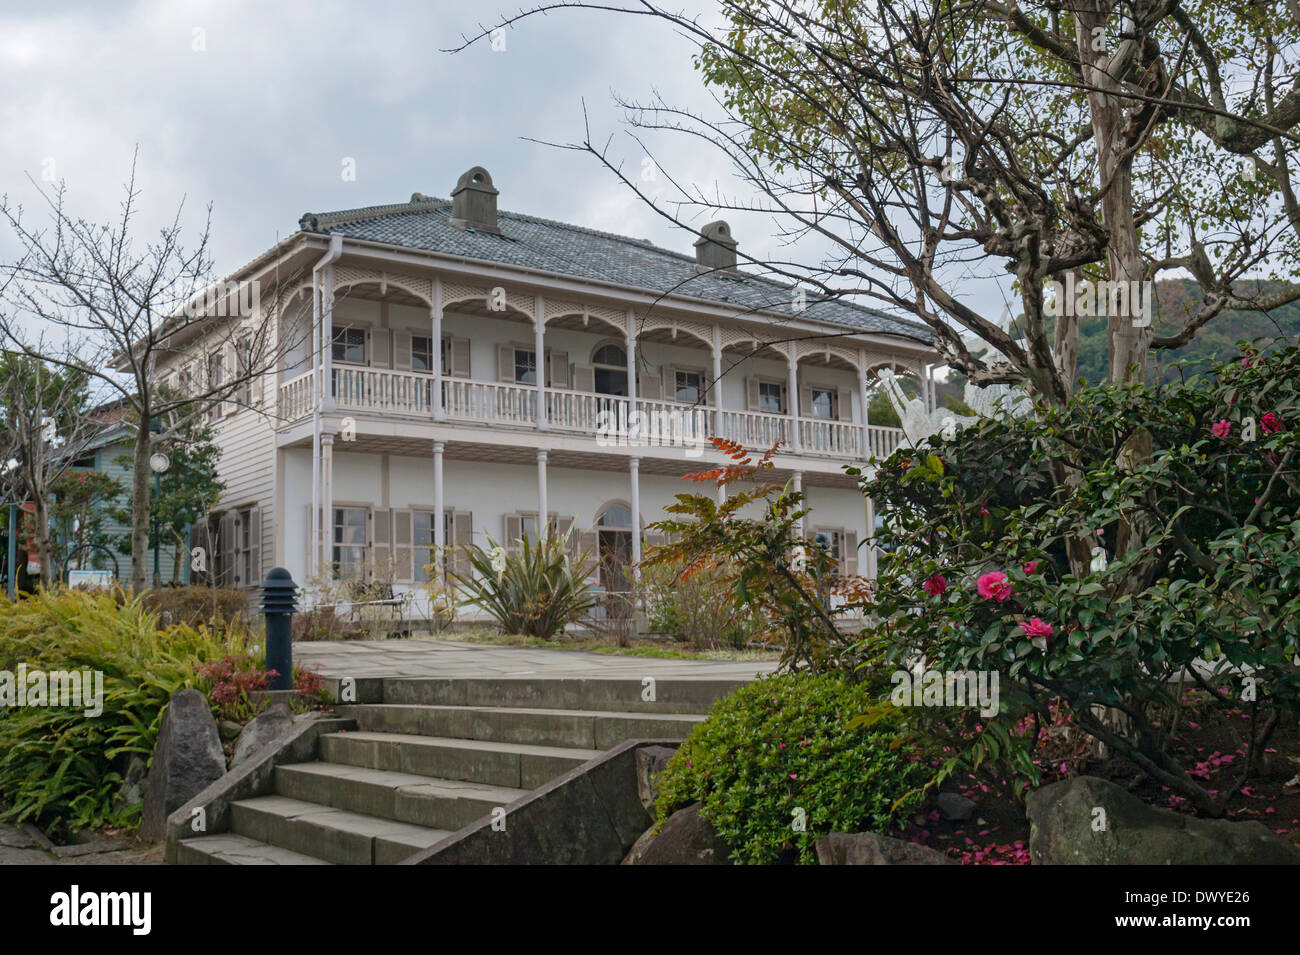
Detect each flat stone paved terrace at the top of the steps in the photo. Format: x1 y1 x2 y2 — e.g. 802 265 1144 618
294 638 776 680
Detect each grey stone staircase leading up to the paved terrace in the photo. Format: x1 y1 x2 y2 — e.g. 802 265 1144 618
176 680 737 865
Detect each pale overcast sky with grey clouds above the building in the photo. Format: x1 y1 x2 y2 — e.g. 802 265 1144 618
0 0 1008 328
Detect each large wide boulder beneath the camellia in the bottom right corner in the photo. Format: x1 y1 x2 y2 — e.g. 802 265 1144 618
1026 776 1300 865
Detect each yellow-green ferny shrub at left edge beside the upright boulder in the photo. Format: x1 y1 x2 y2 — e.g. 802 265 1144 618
0 590 247 829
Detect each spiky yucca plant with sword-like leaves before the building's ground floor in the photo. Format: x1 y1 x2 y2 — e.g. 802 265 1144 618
452 534 595 641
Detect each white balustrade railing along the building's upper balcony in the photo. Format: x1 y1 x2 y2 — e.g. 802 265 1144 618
278 365 902 461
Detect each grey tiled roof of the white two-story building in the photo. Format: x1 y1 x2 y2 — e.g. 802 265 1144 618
299 194 933 343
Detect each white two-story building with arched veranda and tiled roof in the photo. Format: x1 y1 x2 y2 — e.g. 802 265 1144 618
174 168 936 615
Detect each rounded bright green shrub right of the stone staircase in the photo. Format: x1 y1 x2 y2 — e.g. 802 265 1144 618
655 672 928 864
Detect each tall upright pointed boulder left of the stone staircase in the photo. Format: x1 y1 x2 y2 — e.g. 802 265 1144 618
140 690 226 842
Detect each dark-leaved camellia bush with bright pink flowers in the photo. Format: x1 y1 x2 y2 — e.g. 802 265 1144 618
862 347 1300 816
